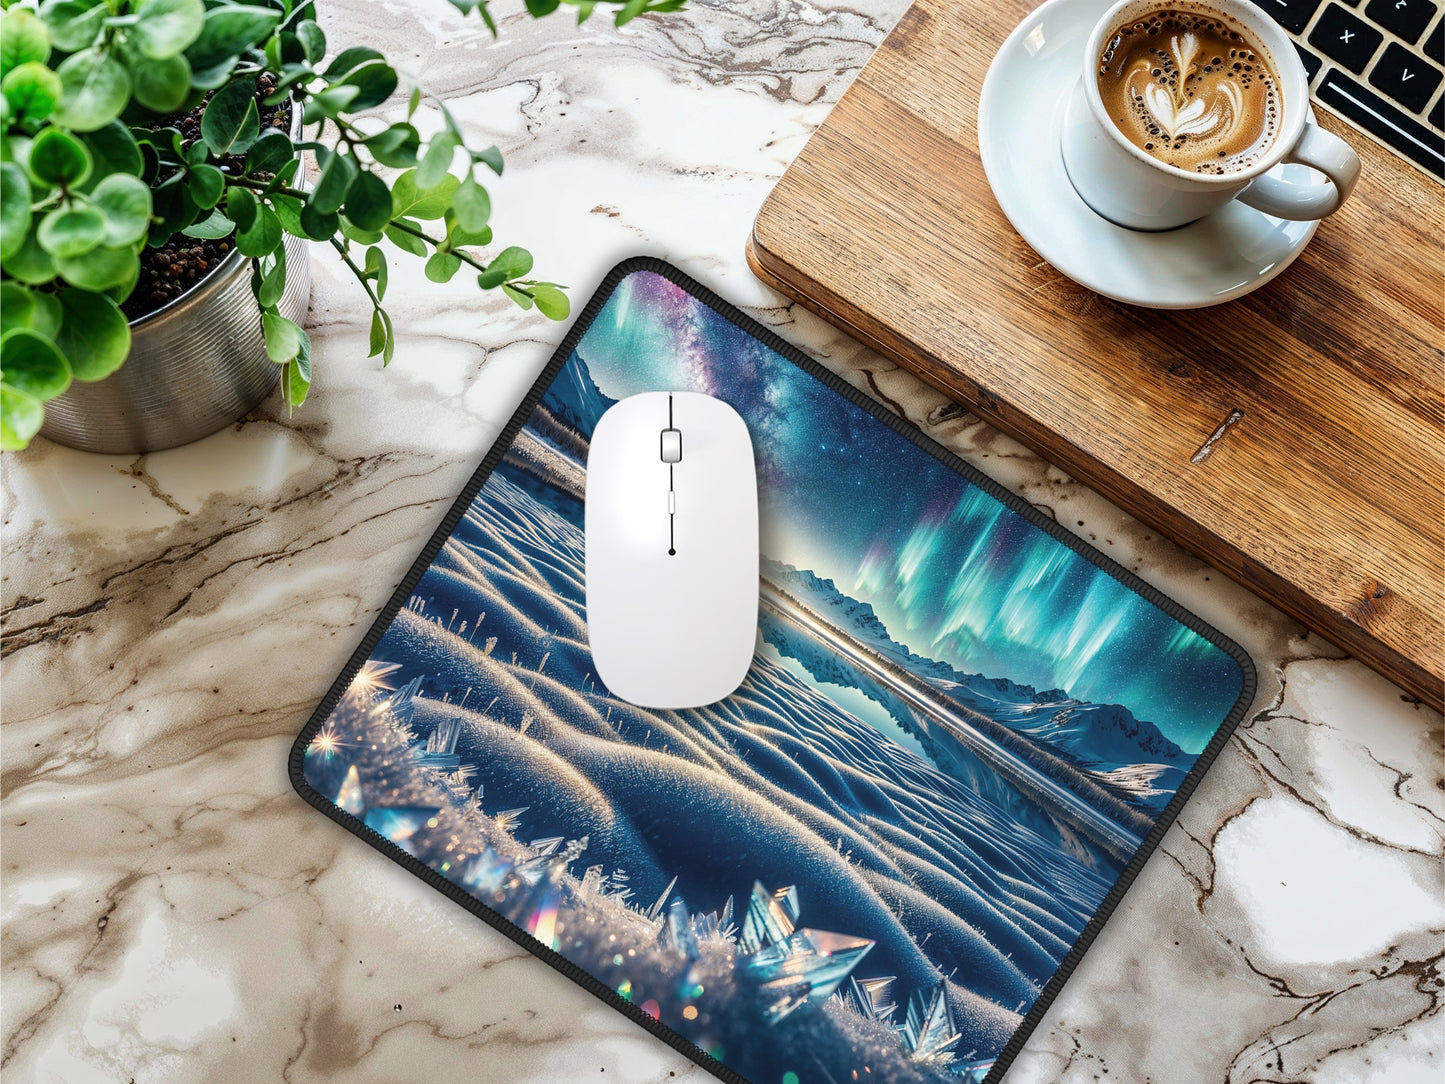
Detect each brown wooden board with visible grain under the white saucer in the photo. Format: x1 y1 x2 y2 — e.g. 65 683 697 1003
749 0 1445 708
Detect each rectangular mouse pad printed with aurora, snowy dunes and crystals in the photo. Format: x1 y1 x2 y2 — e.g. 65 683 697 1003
290 259 1254 1084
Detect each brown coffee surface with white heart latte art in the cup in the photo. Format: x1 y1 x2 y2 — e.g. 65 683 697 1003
1098 7 1280 173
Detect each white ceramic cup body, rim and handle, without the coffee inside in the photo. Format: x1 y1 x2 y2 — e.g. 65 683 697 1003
1062 0 1360 230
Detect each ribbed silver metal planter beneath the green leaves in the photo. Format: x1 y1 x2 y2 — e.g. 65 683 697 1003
40 234 311 452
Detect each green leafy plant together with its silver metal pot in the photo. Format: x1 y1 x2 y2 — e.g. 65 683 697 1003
0 0 683 451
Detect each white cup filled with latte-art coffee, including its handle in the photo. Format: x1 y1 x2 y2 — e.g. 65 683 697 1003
1062 0 1360 230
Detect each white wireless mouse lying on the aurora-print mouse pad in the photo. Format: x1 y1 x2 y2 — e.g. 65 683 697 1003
584 392 759 708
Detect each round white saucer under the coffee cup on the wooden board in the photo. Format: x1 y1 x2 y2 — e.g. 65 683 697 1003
978 0 1328 309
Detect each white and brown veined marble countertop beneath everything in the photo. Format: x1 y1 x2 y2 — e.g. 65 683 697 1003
0 0 1445 1084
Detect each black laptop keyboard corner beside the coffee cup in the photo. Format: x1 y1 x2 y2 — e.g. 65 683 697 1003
1256 0 1445 181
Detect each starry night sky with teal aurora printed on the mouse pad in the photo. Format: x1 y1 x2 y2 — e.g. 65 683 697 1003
578 272 1241 753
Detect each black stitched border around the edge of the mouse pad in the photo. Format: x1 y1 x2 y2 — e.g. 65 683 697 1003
289 256 1259 1084
